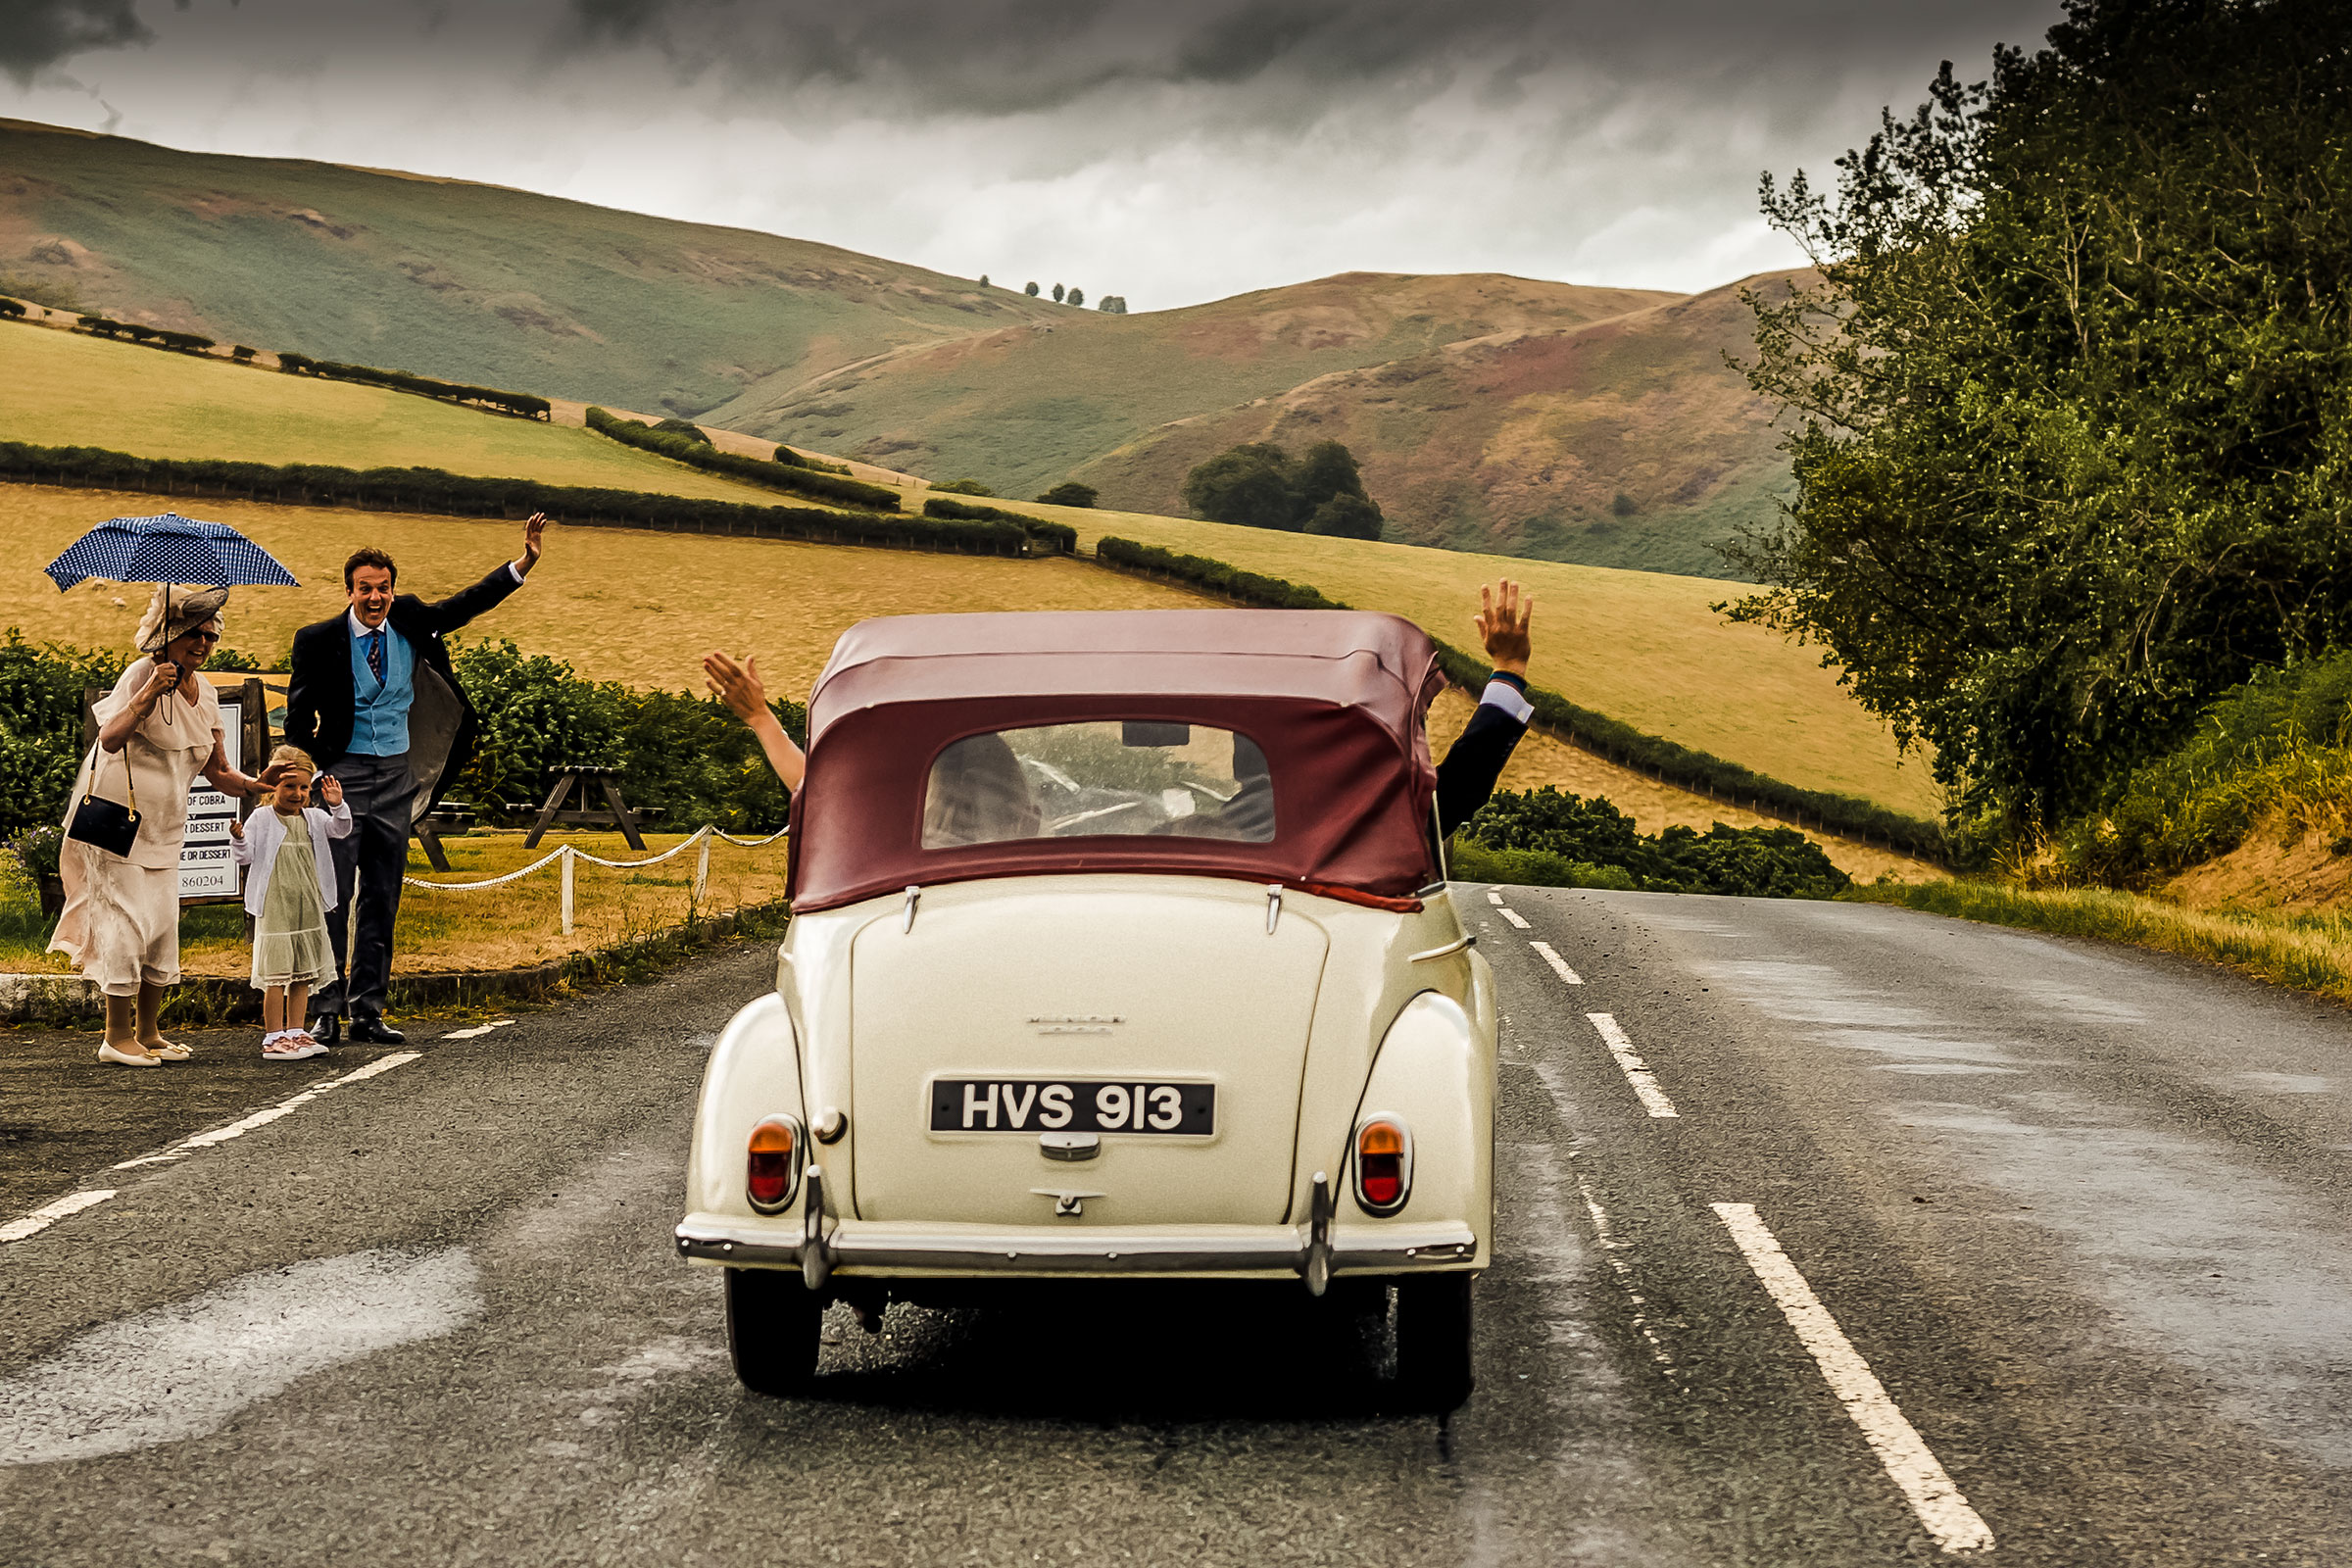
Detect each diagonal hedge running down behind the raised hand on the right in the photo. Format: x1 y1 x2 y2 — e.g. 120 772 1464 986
1094 538 1945 862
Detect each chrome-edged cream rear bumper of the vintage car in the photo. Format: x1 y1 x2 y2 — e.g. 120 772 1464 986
677 1215 1484 1279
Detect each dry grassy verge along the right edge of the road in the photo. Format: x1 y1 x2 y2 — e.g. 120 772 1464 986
1844 882 2352 1002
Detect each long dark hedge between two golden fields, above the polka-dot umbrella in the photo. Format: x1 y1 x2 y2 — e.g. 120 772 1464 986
0 442 1025 555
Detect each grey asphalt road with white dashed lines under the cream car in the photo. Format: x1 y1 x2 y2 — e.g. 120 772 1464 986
0 889 2352 1568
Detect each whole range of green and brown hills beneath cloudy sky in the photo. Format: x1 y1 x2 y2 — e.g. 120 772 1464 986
0 120 1788 576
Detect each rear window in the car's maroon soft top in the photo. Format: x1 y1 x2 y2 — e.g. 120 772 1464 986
922 719 1275 849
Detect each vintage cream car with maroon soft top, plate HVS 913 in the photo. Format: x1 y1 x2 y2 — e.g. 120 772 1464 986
677 609 1495 1410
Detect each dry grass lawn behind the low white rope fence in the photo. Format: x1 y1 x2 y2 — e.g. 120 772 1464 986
0 832 783 978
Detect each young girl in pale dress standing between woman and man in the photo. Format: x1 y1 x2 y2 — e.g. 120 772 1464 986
228 745 351 1062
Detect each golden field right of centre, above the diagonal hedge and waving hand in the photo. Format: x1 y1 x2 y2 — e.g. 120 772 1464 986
1049 506 1940 815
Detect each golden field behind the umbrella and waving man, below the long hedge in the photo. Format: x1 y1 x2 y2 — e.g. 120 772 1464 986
0 484 1209 698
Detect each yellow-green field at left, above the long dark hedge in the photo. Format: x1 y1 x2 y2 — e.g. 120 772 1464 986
0 322 793 506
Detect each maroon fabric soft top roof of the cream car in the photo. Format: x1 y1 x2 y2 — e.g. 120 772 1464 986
790 609 1445 909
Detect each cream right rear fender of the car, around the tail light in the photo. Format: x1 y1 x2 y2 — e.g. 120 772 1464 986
1341 990 1494 1257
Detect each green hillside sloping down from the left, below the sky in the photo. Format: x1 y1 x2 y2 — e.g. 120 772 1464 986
0 120 1062 414
